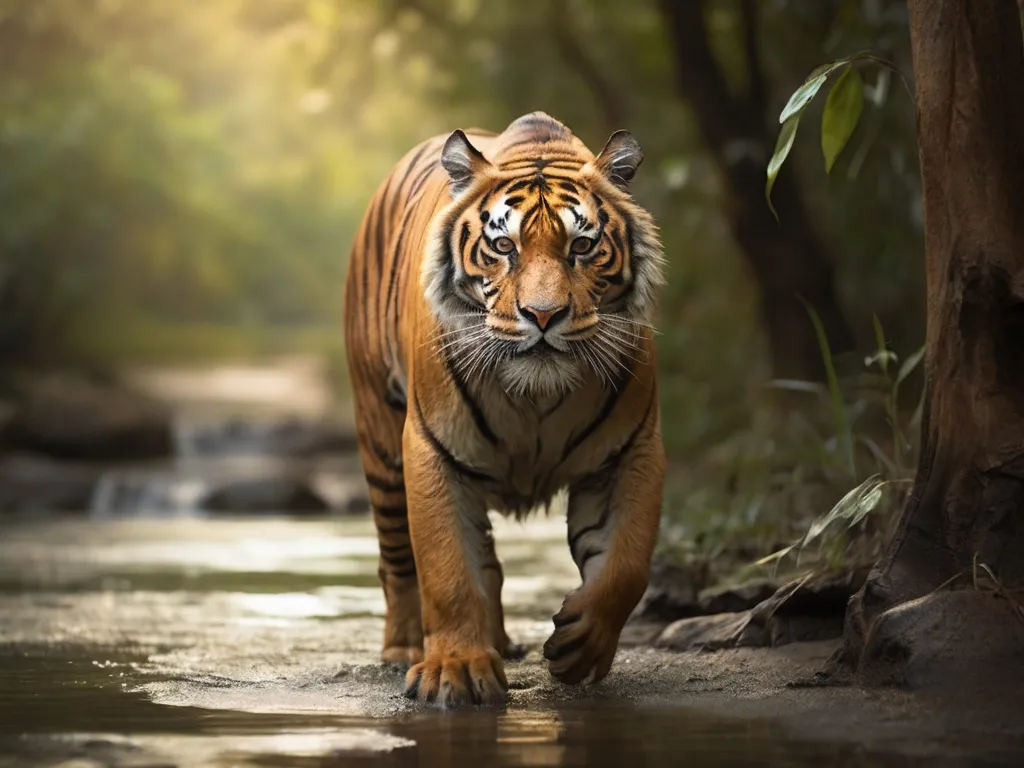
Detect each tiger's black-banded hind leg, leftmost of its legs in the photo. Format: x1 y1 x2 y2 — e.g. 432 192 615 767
353 386 423 665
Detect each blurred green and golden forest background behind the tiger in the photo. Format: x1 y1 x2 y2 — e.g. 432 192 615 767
0 0 924 573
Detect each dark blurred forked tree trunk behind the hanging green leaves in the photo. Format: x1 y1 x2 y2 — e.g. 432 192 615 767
660 0 856 380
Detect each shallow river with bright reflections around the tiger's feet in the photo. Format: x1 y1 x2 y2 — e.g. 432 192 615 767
0 518 978 768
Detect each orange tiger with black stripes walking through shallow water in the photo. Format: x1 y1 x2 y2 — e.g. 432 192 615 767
343 112 666 709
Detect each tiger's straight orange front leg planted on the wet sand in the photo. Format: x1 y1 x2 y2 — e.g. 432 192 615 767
403 417 508 708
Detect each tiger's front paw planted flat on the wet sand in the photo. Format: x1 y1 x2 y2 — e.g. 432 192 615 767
406 646 509 709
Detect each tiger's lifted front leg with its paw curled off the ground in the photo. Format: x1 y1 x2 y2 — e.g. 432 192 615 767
544 409 665 684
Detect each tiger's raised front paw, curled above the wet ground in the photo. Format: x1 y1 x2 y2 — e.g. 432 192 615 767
544 592 622 685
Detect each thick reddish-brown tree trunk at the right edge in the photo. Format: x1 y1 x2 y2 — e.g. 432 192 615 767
837 0 1024 682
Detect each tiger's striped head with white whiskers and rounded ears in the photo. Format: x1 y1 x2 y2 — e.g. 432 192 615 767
422 113 664 394
